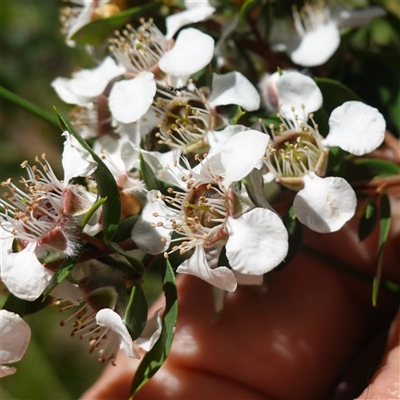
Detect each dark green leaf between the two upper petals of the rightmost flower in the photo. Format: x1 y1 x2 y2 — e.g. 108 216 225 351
314 78 360 114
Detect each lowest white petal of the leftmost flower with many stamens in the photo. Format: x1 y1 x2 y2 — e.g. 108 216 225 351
1 243 52 301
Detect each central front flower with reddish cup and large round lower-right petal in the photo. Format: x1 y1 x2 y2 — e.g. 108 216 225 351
132 153 288 291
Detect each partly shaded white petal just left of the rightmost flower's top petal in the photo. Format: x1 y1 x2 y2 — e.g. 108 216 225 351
208 71 260 111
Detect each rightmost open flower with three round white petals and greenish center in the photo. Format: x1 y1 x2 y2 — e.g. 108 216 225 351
222 72 385 232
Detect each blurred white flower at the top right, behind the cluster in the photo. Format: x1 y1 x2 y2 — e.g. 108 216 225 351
271 3 385 67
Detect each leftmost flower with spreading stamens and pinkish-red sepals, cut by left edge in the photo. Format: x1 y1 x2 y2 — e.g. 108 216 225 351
0 132 97 300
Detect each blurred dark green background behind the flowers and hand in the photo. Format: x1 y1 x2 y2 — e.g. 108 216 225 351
0 0 400 400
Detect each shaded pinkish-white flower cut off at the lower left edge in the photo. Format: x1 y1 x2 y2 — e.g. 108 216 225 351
0 310 31 378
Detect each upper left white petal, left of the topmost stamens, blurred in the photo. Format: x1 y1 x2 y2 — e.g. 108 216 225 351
71 57 125 98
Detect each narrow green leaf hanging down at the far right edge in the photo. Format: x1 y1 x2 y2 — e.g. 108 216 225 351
372 193 391 307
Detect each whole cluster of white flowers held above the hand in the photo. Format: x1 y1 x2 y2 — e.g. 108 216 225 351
0 0 394 396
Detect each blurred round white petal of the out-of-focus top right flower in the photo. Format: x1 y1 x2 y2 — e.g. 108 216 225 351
288 22 340 67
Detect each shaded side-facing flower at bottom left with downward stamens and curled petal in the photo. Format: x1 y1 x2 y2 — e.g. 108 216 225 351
51 261 161 365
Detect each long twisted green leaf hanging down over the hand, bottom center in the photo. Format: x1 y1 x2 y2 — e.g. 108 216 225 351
130 260 178 399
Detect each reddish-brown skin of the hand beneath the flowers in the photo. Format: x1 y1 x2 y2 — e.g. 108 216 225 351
82 220 400 400
